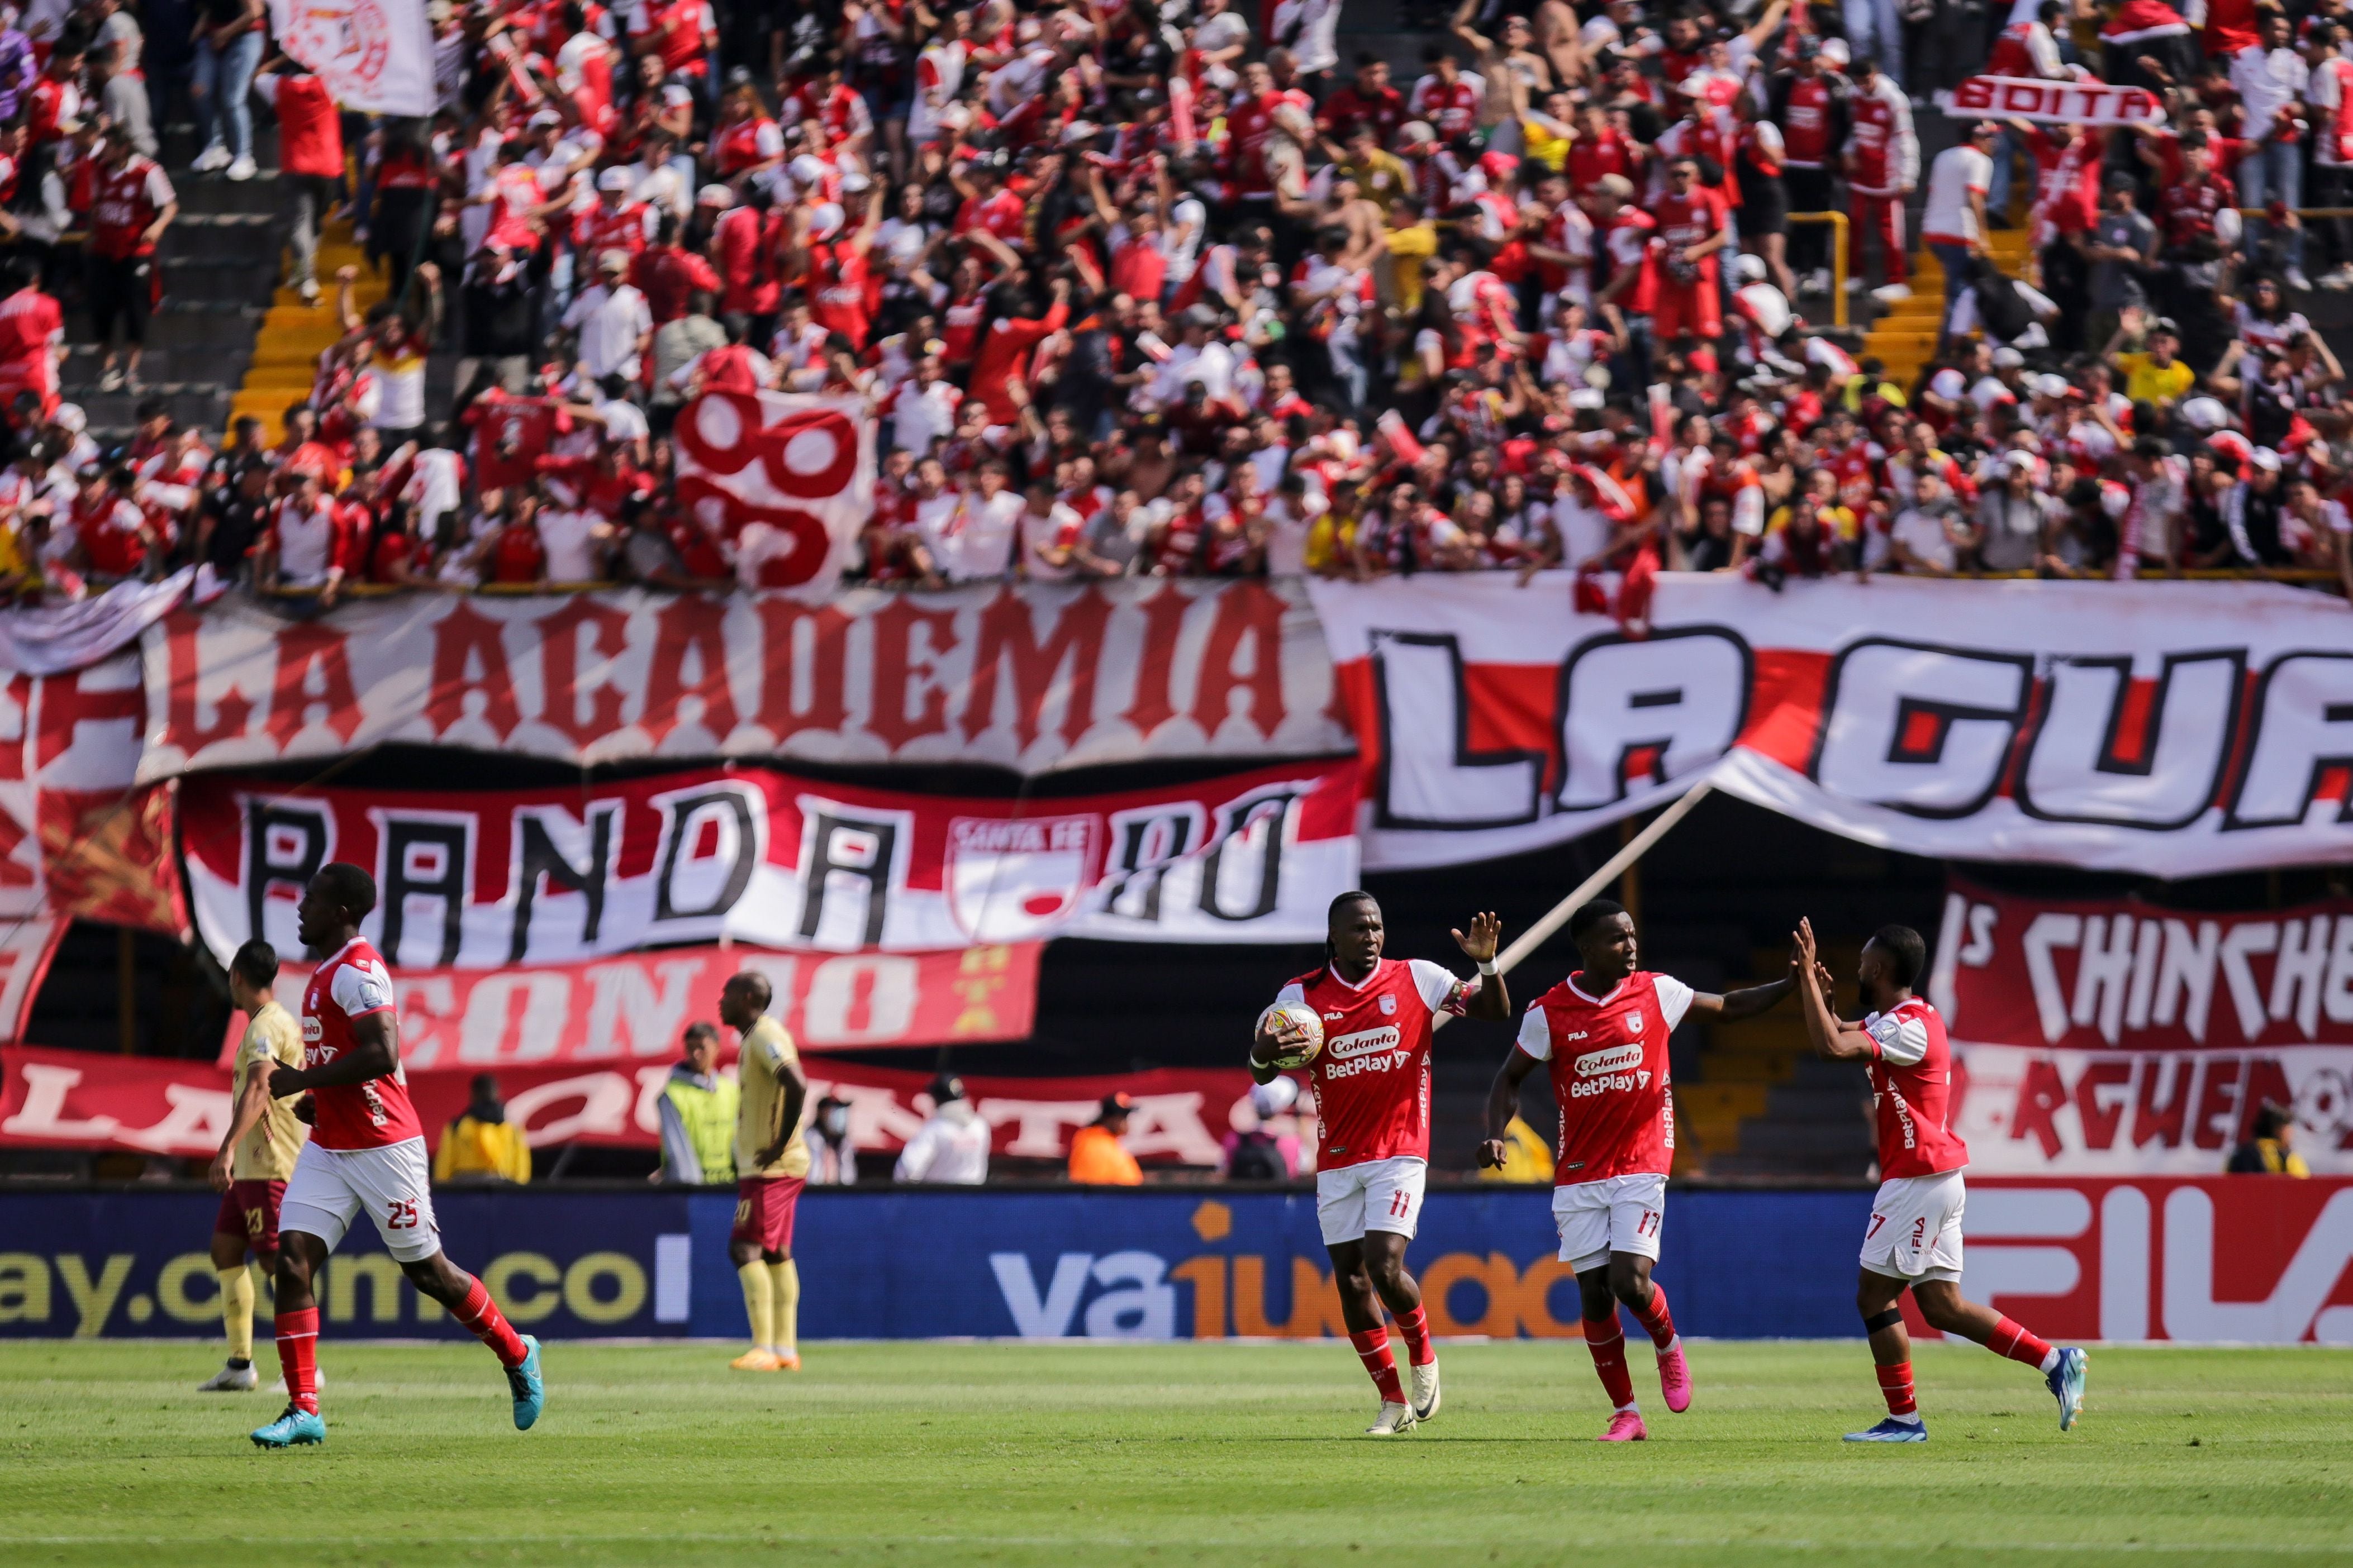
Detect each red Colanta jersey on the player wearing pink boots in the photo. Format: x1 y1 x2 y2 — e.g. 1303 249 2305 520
1520 969 1692 1187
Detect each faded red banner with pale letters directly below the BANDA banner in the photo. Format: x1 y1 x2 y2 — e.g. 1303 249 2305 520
214 943 1038 1072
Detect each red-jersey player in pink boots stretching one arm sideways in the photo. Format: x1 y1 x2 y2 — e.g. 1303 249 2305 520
1478 898 1798 1443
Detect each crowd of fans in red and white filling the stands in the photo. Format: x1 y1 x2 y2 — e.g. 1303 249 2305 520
0 0 2353 613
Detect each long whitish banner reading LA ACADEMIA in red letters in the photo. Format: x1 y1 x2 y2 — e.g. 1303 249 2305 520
139 578 1351 780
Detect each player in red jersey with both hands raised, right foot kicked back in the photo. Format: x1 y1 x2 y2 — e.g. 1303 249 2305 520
1798 919 2089 1443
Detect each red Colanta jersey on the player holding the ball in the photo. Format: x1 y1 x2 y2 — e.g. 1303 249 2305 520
1275 959 1468 1171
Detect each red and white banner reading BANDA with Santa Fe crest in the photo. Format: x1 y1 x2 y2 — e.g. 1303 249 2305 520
181 757 1356 969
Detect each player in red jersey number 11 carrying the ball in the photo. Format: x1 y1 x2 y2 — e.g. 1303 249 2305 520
1249 893 1510 1436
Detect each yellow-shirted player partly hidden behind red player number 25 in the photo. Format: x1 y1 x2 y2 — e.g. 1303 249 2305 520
198 940 311 1394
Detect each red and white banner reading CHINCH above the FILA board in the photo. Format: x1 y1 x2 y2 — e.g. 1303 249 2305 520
1927 879 2353 1175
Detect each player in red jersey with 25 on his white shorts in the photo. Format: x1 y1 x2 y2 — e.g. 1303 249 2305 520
254 860 546 1448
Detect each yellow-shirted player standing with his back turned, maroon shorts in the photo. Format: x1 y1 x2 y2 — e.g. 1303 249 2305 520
720 971 810 1373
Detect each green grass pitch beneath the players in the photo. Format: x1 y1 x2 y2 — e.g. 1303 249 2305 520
0 1340 2353 1568
